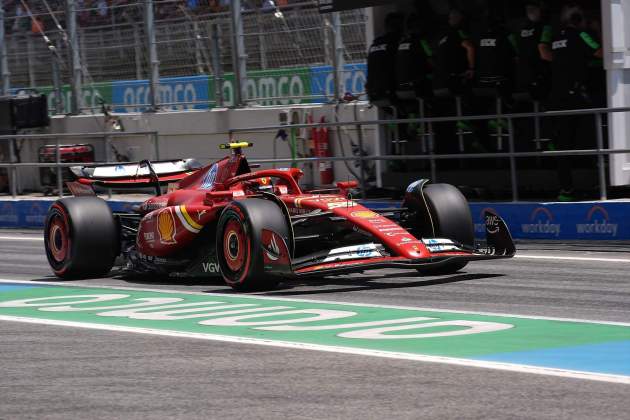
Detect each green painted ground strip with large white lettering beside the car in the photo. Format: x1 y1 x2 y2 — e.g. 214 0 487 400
0 287 630 358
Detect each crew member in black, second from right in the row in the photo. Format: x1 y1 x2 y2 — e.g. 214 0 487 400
516 0 553 95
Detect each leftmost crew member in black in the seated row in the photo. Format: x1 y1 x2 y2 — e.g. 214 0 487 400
365 13 405 102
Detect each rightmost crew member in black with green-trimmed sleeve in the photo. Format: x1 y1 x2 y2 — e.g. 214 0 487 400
551 5 602 201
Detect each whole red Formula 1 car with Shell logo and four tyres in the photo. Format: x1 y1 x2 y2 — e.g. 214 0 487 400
45 143 515 290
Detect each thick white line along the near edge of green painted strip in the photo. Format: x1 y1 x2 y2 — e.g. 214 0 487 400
0 315 630 385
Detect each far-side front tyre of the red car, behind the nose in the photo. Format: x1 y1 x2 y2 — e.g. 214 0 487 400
403 184 475 275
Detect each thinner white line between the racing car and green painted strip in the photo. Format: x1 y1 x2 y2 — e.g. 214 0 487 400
0 279 630 327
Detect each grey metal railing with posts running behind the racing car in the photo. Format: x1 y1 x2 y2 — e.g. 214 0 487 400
0 108 630 202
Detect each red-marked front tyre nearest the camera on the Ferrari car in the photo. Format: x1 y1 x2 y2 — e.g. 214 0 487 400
216 198 292 291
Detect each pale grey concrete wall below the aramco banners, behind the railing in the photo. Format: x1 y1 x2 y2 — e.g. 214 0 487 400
12 103 381 191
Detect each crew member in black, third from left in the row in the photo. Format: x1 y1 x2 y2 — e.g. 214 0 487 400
435 9 475 87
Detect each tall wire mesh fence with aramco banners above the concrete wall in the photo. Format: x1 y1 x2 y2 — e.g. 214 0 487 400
3 0 367 112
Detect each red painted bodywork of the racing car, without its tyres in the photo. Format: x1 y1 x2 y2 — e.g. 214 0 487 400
71 148 516 275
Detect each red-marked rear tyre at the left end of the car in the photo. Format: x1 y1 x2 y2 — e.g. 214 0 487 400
44 197 120 279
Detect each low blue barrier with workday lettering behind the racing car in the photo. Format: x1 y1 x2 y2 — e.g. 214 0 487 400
0 200 630 240
